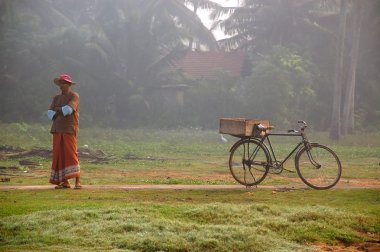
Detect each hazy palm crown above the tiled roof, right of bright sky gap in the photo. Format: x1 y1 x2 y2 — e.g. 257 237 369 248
211 0 319 53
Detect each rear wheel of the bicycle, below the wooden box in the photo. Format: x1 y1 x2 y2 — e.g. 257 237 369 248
229 139 270 186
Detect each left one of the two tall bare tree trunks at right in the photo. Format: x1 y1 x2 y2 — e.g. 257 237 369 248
330 0 347 140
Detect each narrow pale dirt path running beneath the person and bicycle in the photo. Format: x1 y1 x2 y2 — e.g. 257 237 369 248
0 184 380 191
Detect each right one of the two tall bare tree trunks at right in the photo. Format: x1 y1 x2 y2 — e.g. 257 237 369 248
341 1 362 136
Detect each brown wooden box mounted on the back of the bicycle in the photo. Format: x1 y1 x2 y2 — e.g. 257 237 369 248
219 118 270 137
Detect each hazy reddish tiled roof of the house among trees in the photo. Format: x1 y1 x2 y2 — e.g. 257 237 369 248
172 51 245 80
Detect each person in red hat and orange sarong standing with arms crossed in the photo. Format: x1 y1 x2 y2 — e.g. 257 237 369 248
48 74 82 189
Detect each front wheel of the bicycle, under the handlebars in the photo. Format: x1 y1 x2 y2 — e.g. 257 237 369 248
295 143 342 189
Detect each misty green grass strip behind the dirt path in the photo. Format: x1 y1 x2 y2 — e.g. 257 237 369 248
0 123 380 185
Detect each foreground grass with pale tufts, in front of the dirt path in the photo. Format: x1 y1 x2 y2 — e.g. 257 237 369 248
0 190 380 251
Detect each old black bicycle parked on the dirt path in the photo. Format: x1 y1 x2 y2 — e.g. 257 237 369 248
229 121 342 189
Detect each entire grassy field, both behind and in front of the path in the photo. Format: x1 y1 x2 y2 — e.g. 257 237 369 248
0 124 380 251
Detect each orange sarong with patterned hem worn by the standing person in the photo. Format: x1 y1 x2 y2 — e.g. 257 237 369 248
50 133 80 185
